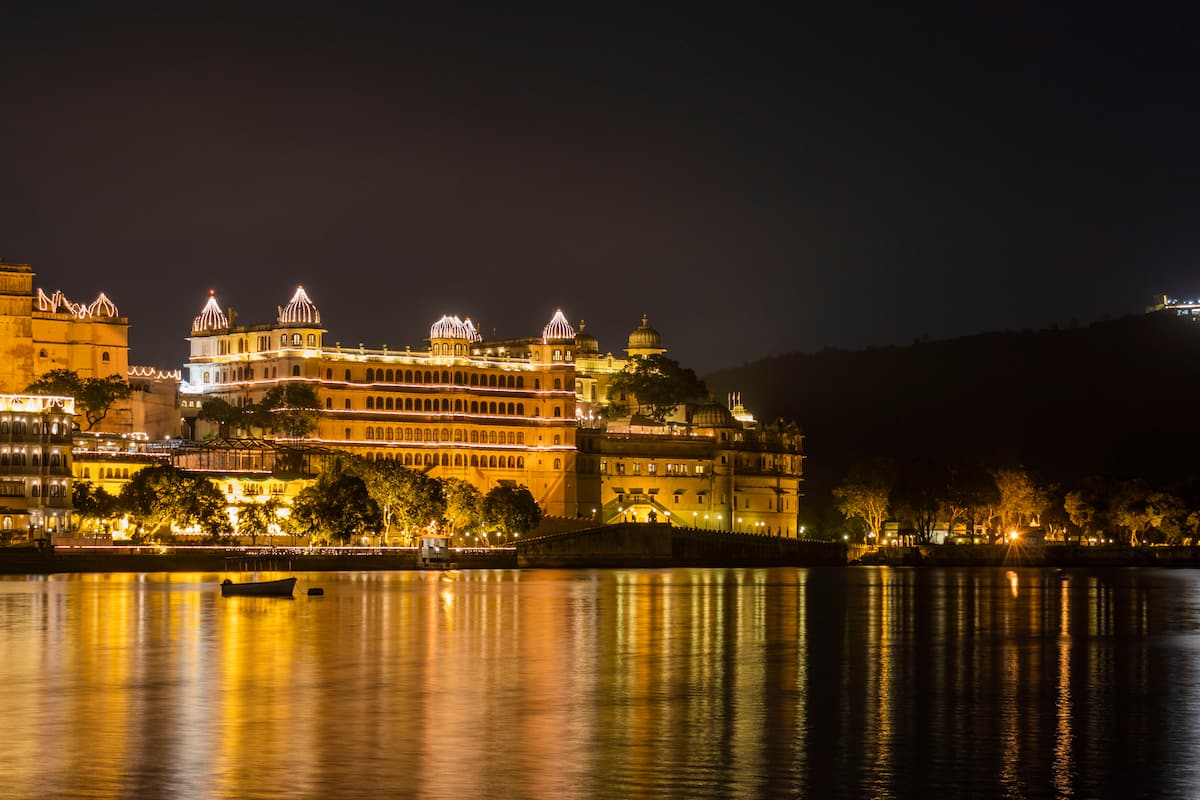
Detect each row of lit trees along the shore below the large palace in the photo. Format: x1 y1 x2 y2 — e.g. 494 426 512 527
72 456 542 546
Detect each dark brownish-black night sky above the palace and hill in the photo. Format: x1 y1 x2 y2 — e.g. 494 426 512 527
0 1 1200 373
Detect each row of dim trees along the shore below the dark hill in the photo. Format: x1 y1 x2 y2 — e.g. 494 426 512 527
823 458 1200 546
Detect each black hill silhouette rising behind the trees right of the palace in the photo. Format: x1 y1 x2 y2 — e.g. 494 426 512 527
706 313 1200 525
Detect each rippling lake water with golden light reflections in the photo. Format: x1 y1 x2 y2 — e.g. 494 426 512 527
0 567 1200 800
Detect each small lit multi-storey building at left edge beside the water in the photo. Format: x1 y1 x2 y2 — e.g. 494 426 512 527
0 395 74 540
